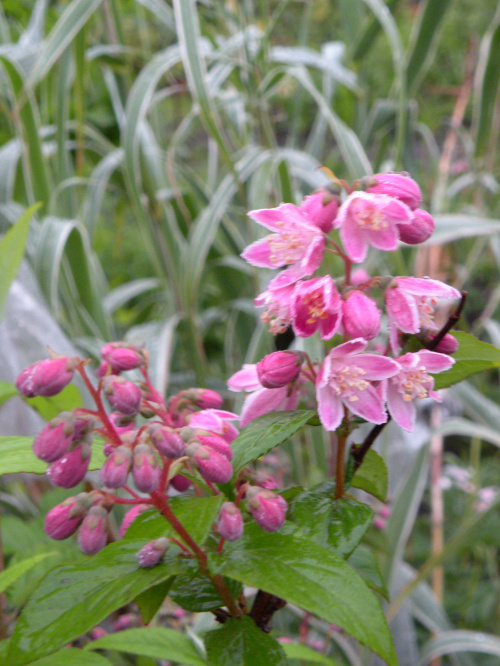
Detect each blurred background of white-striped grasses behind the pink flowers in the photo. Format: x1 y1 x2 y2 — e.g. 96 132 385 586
0 0 500 665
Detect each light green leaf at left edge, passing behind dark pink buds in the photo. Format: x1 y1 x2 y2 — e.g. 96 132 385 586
0 435 105 476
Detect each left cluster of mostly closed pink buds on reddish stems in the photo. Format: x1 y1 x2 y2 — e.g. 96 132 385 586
16 342 287 556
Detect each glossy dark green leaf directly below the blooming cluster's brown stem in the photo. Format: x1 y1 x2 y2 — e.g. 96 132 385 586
292 483 373 558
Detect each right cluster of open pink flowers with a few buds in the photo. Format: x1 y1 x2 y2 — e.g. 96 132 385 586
228 173 461 431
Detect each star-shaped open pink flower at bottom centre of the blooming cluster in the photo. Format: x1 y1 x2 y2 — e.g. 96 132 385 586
316 338 399 431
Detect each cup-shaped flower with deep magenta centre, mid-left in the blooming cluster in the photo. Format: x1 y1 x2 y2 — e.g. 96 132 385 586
290 275 342 340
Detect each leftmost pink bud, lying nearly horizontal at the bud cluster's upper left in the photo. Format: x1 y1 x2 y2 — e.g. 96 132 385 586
16 356 75 398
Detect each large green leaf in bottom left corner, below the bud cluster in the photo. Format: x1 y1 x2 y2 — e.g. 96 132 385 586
7 539 185 666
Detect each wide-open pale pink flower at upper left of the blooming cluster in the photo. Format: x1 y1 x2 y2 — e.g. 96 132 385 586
241 204 325 286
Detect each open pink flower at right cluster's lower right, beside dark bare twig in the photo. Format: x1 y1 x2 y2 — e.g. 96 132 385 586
387 350 455 432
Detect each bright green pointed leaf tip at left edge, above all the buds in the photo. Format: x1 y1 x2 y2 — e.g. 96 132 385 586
0 204 41 321
